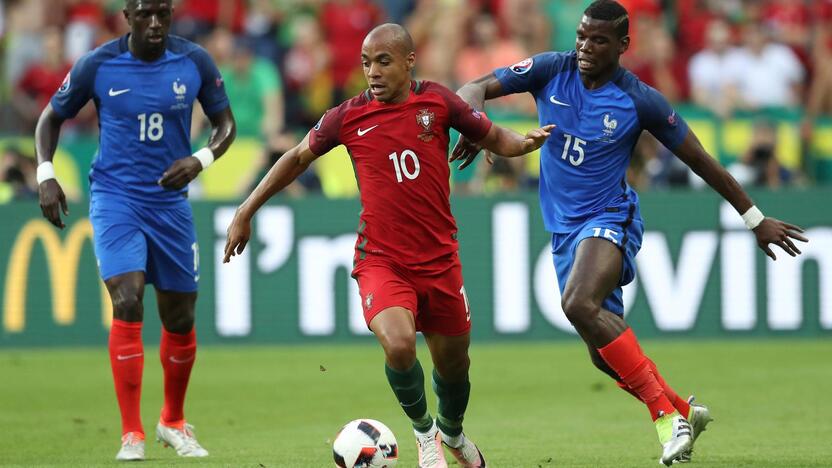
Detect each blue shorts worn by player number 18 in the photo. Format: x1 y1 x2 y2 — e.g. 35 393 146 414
90 194 199 292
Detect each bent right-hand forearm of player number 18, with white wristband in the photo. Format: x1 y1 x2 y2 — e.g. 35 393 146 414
159 107 237 190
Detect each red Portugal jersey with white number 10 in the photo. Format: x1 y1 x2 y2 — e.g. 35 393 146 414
309 81 491 269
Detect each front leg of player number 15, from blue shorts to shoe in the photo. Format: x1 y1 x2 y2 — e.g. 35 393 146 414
562 238 693 465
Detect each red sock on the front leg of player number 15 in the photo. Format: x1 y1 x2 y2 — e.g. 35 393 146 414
598 328 678 421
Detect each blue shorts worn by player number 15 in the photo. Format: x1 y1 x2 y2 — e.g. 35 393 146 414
552 204 644 316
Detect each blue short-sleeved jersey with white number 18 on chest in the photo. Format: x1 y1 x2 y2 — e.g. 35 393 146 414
51 35 229 203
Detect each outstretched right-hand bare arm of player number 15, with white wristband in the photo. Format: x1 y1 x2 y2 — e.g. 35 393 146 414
674 130 808 260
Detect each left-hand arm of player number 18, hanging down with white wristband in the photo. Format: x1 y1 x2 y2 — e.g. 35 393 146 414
35 103 69 229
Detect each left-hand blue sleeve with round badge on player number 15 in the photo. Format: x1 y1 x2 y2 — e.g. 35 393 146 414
494 52 571 94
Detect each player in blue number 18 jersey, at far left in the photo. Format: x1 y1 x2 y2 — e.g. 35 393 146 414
35 0 235 460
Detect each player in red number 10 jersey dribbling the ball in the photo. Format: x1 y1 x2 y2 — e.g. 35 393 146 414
224 24 552 468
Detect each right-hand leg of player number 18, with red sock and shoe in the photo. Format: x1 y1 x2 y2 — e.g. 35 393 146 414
156 289 208 457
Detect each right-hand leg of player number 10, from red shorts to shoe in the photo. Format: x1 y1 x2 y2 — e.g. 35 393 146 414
424 333 486 468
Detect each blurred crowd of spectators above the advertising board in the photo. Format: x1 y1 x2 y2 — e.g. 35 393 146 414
0 0 832 200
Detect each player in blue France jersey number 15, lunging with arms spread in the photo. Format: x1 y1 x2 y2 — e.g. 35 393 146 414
451 0 806 465
